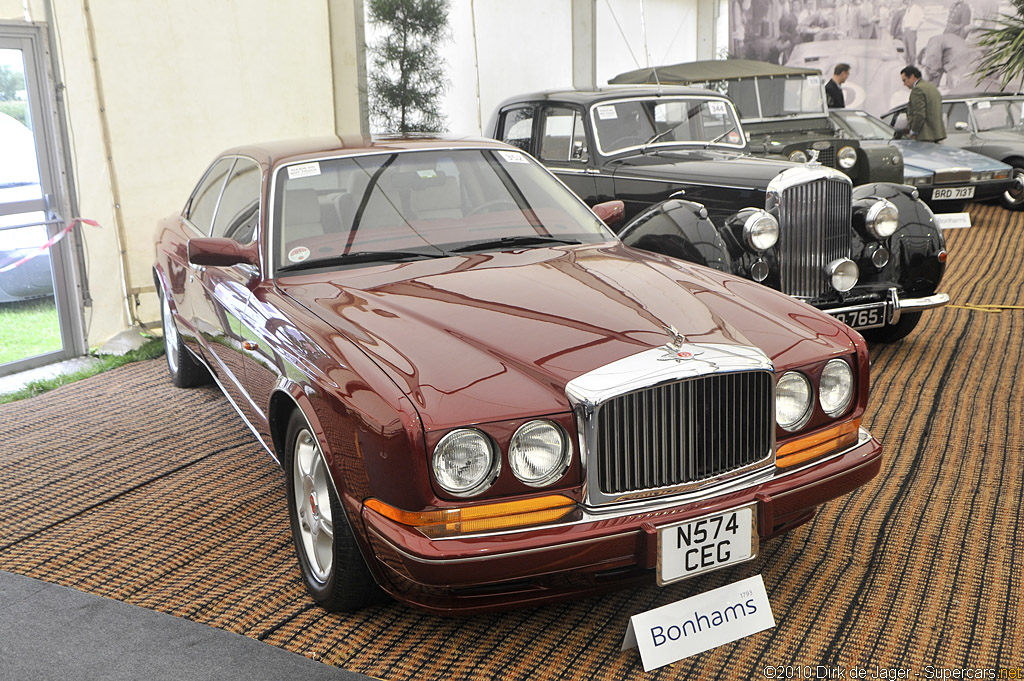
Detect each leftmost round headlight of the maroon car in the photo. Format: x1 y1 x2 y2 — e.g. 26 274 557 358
433 428 500 497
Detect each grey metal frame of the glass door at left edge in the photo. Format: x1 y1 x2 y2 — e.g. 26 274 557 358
0 22 87 376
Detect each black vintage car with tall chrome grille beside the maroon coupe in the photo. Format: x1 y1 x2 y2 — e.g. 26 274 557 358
487 87 949 341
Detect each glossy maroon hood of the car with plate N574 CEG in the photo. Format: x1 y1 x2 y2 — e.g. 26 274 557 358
278 243 854 430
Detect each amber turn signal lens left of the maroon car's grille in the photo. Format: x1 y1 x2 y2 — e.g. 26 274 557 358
366 495 575 538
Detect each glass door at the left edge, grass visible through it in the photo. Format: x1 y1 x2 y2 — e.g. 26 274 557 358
0 25 78 375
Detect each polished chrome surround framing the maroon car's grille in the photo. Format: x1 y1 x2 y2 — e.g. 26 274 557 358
565 343 775 506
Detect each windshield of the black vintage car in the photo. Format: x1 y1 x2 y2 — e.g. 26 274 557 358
590 97 744 155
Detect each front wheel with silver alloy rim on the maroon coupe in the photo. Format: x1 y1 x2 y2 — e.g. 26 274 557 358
283 410 383 612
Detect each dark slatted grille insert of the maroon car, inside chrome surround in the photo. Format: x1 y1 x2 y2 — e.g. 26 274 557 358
592 371 774 495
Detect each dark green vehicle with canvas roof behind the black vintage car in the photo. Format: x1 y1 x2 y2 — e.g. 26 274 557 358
609 59 903 184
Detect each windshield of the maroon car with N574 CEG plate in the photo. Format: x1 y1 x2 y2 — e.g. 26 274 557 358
272 148 614 271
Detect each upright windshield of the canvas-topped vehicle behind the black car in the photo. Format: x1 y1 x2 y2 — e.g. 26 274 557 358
726 74 825 121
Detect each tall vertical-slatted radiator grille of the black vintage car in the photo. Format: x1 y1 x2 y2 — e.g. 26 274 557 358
778 178 852 298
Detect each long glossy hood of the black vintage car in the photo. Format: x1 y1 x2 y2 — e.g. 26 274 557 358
612 150 793 189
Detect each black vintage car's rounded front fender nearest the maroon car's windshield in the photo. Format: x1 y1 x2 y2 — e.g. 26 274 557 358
618 199 733 272
